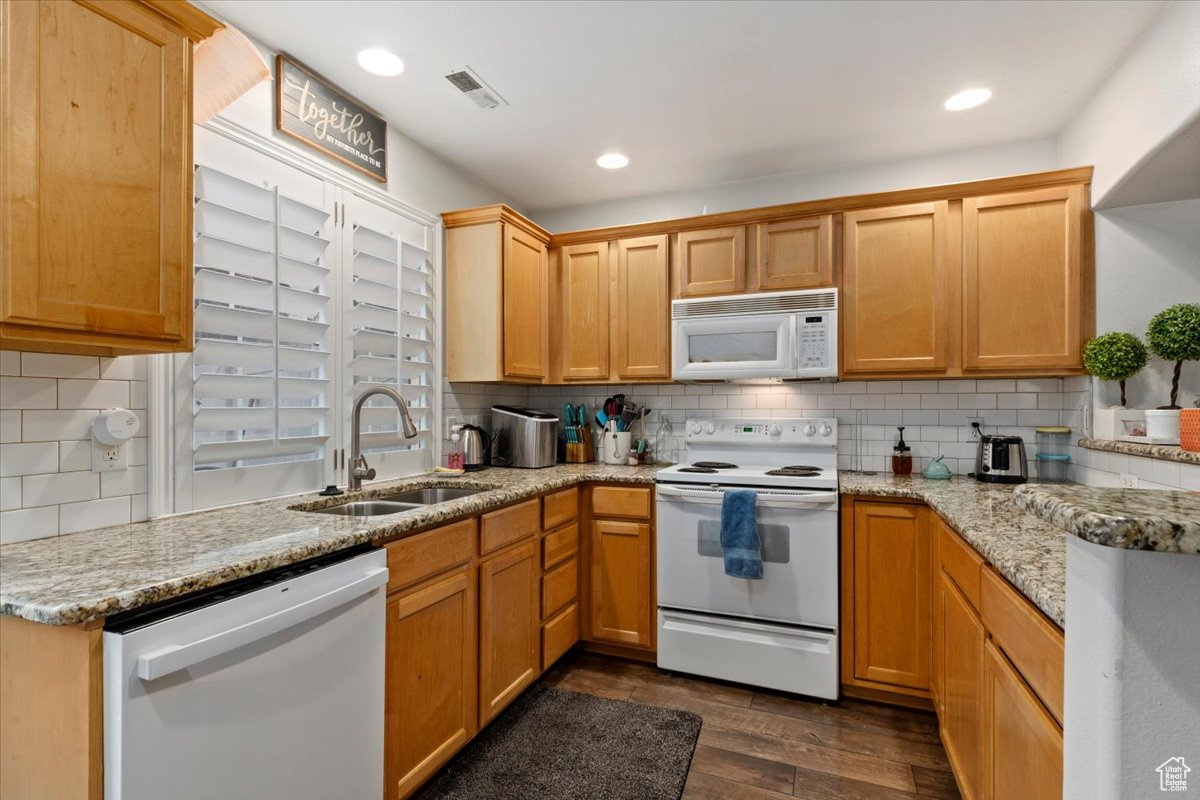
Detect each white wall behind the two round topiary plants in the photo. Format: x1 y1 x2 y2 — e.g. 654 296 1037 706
1096 199 1200 408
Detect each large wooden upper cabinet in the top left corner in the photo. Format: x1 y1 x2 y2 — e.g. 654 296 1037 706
0 1 221 355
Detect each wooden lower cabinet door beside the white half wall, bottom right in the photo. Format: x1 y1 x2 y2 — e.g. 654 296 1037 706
979 640 1062 800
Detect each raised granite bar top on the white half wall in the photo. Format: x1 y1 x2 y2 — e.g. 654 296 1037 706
1013 483 1200 553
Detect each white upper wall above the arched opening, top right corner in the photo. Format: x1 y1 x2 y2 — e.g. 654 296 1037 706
1058 0 1200 207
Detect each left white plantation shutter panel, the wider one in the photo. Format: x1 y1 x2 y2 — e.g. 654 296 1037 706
183 160 334 509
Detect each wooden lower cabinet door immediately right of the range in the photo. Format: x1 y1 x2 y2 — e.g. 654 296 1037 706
852 500 931 691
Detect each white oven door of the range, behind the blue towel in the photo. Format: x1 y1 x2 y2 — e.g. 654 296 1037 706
658 483 838 630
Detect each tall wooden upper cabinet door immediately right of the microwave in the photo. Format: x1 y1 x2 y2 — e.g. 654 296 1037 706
841 200 956 374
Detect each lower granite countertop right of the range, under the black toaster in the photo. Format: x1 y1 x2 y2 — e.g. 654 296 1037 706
840 473 1067 627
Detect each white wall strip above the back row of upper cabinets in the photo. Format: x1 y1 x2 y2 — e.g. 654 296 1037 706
529 138 1056 233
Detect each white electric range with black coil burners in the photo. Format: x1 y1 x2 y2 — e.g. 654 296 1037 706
655 417 838 699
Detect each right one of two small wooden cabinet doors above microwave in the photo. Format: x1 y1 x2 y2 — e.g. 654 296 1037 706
755 213 834 291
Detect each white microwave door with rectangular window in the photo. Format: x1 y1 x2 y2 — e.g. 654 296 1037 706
671 313 799 380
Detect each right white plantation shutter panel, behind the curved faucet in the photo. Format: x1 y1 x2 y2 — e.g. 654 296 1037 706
342 194 437 480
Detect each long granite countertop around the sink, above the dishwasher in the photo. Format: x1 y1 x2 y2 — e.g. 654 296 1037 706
0 464 659 625
